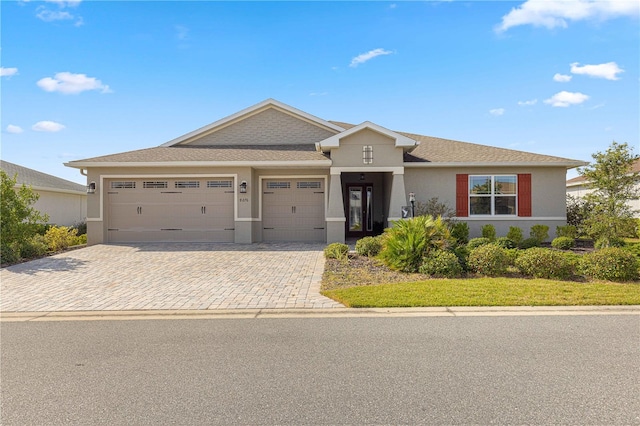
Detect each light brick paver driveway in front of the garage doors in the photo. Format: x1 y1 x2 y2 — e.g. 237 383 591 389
0 243 342 312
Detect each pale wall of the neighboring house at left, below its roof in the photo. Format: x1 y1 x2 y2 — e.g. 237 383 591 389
33 190 87 226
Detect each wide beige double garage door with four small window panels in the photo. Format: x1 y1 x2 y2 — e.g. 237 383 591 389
105 178 234 242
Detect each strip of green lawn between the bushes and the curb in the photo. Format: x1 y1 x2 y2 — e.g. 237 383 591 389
322 278 640 308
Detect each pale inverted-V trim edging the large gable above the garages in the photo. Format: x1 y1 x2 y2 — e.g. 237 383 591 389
160 99 344 147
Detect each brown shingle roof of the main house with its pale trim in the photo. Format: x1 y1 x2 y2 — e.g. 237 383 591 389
66 99 587 168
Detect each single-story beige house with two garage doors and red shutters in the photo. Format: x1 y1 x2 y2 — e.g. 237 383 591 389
66 99 584 244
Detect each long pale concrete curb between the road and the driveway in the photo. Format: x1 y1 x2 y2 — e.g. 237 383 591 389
0 305 640 322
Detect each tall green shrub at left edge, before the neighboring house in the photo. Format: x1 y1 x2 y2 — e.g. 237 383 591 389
0 170 49 262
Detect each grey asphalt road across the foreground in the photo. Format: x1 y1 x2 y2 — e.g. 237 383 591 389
0 315 640 425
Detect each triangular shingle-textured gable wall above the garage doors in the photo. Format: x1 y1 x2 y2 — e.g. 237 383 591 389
188 108 335 145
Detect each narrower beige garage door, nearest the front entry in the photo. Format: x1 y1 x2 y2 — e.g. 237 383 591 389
262 179 326 241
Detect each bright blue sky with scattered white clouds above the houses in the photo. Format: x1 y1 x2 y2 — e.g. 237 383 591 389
0 0 640 183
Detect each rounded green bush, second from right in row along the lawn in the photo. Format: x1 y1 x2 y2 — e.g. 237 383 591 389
515 247 576 280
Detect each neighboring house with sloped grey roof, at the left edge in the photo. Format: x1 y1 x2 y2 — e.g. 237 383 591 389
0 160 87 226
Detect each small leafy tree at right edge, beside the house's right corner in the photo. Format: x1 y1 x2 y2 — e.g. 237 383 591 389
578 141 640 245
